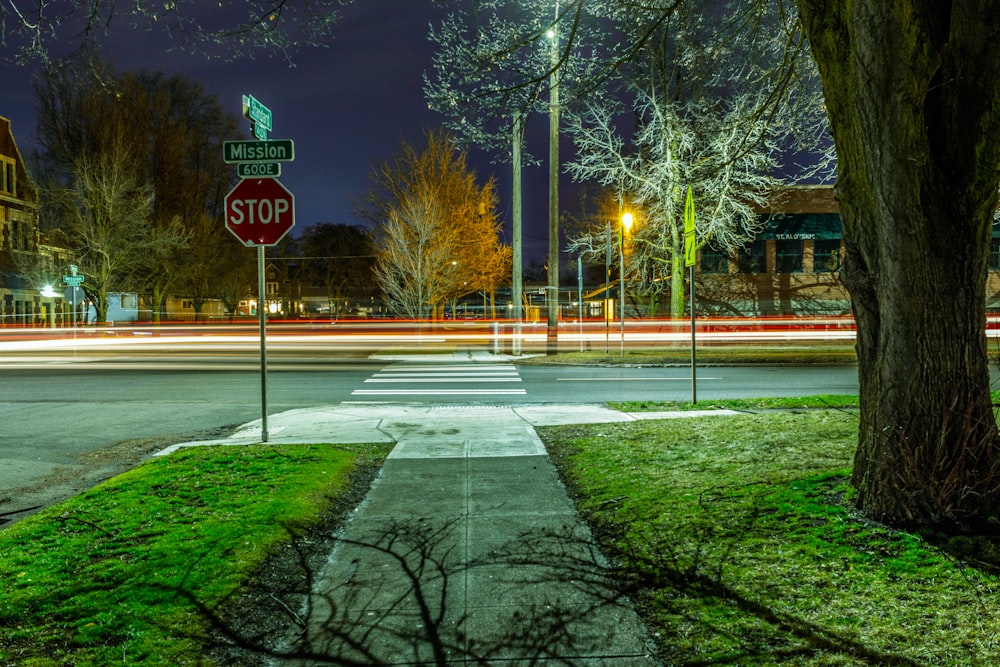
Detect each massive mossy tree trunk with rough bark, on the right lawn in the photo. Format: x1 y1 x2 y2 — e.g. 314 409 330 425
798 0 1000 526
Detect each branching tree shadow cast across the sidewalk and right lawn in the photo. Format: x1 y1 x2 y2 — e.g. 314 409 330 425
166 486 944 667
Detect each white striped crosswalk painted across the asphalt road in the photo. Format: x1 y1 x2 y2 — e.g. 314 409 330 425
351 362 526 397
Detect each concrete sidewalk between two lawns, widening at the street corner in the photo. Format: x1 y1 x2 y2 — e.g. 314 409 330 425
160 405 744 666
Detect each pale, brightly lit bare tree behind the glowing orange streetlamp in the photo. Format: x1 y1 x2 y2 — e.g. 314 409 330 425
569 95 773 317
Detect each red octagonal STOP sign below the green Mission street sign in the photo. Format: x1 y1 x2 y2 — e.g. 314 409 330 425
226 178 295 246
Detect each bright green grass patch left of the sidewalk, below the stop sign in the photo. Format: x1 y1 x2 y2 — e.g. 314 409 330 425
0 445 387 667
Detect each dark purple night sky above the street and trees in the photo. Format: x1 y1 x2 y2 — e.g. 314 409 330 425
0 0 556 261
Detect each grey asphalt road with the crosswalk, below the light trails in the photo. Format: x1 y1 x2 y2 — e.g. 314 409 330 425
0 356 857 522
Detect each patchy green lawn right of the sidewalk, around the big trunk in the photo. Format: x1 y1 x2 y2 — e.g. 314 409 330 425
539 410 1000 667
